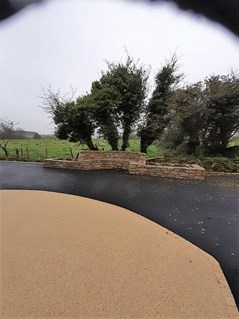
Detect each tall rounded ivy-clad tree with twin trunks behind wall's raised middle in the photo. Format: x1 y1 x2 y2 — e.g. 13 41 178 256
91 55 148 151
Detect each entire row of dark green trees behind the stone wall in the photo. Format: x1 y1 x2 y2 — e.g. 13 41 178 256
43 56 239 156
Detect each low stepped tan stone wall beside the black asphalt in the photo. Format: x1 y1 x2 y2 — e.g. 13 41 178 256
43 151 205 180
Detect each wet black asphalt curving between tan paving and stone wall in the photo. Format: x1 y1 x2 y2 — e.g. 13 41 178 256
0 162 239 308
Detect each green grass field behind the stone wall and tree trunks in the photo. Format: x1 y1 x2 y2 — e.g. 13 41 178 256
0 139 164 161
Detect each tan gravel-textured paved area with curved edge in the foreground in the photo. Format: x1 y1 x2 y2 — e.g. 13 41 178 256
1 191 238 319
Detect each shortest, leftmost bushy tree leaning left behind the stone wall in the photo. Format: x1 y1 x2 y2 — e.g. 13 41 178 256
42 88 97 150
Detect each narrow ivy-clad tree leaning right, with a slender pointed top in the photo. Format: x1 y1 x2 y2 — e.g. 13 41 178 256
139 56 181 153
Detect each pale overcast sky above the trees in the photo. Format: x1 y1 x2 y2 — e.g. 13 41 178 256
0 0 239 133
